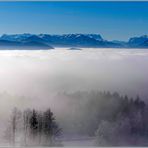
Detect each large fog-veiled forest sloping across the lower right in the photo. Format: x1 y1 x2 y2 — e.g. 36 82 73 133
54 91 148 146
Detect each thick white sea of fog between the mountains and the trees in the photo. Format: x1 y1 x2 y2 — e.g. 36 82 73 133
0 48 148 120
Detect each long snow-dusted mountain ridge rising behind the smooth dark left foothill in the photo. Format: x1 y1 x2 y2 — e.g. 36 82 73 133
0 34 120 47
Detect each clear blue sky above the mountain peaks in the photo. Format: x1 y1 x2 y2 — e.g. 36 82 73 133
0 2 148 40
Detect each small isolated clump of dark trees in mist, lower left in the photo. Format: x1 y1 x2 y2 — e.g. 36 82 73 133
5 108 62 146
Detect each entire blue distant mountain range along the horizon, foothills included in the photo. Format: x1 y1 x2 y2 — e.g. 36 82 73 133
0 34 148 49
